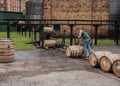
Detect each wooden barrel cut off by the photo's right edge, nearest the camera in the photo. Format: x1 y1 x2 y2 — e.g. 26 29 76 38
112 59 120 78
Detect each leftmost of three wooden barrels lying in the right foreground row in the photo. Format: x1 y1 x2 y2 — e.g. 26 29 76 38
89 51 112 67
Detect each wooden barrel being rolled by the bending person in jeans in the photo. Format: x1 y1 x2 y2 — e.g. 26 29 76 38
66 45 83 57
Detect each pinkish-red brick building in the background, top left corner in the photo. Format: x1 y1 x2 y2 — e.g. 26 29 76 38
0 0 28 12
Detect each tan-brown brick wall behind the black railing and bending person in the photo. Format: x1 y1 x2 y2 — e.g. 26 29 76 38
43 0 109 36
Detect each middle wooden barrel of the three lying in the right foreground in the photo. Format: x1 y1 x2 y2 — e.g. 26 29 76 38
100 54 120 72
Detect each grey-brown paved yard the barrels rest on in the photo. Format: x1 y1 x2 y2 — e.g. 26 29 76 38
0 46 120 86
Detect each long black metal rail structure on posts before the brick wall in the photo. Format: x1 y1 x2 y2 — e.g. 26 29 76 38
2 19 120 46
